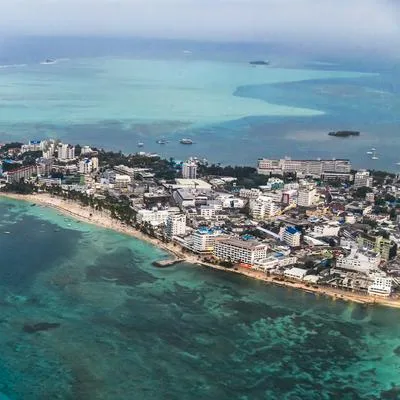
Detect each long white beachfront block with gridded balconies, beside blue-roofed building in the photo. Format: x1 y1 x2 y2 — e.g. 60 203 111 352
214 238 267 265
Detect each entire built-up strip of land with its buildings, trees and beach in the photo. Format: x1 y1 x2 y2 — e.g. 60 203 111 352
0 140 400 307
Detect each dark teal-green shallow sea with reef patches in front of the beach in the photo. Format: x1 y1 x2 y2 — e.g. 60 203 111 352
0 199 400 400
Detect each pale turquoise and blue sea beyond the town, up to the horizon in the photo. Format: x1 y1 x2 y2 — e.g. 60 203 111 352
0 38 400 171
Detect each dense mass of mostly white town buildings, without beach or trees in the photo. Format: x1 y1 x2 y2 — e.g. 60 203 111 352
0 141 400 296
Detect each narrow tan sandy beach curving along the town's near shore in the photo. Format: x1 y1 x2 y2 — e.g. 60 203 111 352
0 192 400 308
